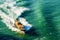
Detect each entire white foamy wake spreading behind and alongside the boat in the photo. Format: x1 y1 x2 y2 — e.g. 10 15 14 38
0 2 30 33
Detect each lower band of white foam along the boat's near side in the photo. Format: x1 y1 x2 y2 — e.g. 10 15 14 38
0 11 24 33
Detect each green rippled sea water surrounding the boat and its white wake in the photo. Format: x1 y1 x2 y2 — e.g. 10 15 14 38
0 0 60 40
